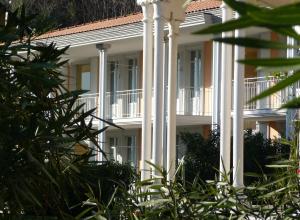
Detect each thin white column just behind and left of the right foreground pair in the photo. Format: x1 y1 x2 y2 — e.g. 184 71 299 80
212 41 221 129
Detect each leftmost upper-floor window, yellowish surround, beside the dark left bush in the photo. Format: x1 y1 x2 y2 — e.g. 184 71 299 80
76 65 91 90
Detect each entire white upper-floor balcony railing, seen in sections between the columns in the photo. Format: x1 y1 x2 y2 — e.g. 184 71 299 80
77 77 300 120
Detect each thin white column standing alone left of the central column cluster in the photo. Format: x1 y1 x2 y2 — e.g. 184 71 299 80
96 44 110 161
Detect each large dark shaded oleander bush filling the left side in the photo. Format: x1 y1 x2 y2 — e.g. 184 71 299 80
0 3 133 219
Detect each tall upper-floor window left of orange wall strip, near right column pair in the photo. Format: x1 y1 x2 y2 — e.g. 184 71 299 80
190 50 201 97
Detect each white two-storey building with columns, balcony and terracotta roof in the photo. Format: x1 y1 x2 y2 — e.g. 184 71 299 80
39 0 298 185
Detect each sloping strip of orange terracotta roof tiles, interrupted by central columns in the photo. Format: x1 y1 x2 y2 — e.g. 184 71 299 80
37 0 221 39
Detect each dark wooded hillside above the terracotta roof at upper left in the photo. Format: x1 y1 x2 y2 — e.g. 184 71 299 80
8 0 140 28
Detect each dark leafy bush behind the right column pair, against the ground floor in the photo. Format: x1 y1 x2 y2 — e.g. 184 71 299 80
180 130 289 184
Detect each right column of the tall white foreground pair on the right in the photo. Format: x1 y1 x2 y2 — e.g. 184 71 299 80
233 15 245 188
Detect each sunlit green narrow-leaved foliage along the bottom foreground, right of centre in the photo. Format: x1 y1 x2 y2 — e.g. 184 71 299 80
82 146 300 219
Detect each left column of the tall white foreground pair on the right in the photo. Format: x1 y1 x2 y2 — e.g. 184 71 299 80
220 3 233 180
